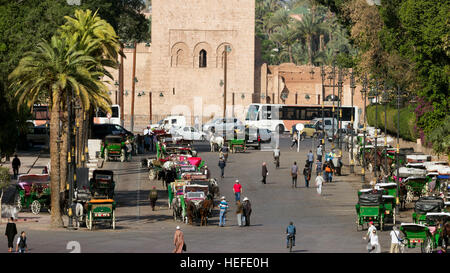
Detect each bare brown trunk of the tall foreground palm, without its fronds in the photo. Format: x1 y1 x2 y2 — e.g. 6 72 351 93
50 97 64 228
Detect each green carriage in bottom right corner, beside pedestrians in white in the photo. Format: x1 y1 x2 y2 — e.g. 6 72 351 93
400 212 450 253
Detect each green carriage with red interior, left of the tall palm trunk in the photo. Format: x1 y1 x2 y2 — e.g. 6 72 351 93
14 174 51 214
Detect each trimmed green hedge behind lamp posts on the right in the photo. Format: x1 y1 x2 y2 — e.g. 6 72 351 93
367 105 419 141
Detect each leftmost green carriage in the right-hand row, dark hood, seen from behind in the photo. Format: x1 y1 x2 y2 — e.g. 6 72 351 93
355 189 385 230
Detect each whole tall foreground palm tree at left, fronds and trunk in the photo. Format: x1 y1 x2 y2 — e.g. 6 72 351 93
9 36 110 227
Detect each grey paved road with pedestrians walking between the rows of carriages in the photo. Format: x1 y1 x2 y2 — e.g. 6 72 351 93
0 137 412 253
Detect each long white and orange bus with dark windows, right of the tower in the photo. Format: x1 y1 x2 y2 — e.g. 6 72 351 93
245 103 360 133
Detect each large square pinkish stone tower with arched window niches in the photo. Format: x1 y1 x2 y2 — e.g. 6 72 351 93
148 0 255 122
